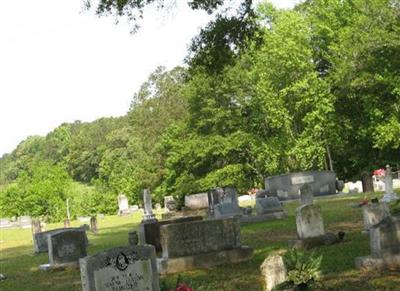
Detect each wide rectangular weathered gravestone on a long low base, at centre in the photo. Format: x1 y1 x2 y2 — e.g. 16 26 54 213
157 217 253 274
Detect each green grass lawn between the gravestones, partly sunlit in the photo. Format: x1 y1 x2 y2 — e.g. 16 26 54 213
0 193 400 291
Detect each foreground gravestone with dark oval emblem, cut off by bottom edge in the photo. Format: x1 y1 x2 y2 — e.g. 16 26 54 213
79 245 160 291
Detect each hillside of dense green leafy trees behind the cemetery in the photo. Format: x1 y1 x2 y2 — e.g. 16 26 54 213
0 0 400 221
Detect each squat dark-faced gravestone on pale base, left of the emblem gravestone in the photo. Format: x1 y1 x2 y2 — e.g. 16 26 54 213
40 228 87 270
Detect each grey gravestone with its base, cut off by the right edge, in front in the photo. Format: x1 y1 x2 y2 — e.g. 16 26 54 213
355 216 400 270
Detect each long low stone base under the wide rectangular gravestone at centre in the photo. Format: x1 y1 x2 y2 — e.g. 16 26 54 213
157 246 253 275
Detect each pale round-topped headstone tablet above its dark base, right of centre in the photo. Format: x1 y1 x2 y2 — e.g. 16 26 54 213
296 204 325 239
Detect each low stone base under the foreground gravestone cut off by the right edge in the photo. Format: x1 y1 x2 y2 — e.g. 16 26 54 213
355 255 400 271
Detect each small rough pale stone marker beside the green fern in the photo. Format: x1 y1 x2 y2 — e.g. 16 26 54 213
261 255 287 291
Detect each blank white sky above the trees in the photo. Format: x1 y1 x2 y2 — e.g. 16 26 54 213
0 0 298 157
